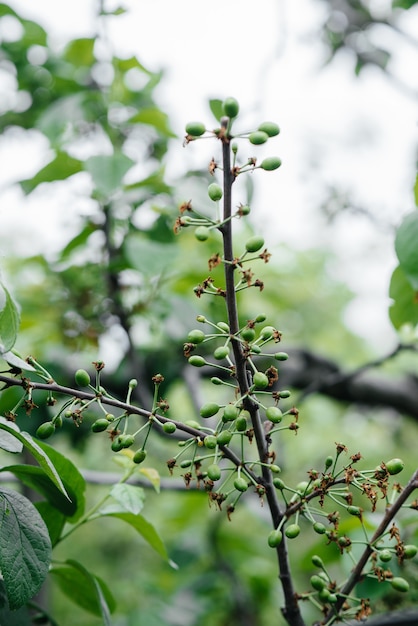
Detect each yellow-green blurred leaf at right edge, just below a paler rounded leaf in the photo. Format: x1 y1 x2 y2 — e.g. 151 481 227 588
389 266 418 330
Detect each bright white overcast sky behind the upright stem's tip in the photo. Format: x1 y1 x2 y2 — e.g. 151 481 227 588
0 0 418 351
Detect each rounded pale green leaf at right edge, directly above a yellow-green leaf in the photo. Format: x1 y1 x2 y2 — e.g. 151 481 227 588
395 211 418 291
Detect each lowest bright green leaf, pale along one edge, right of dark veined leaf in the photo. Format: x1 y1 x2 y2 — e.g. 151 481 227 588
50 559 116 626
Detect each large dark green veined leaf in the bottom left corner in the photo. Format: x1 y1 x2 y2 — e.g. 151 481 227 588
0 489 51 609
